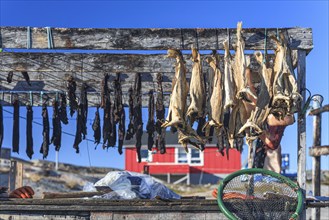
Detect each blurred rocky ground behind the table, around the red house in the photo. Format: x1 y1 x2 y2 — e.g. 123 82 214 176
0 160 329 219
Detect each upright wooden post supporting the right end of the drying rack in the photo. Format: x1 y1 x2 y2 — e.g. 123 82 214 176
297 50 306 219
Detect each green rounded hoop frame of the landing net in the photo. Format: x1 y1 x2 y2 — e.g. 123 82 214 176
217 168 304 220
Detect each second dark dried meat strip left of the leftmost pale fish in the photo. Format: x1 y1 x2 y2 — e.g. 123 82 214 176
146 89 155 151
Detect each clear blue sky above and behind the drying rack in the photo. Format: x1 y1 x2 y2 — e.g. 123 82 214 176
0 0 329 172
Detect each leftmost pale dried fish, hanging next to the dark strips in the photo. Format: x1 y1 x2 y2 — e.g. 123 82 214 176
161 49 204 152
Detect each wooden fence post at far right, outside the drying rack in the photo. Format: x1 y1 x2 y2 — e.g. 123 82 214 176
312 100 321 220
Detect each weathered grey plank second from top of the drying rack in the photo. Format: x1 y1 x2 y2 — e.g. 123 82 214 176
0 52 274 74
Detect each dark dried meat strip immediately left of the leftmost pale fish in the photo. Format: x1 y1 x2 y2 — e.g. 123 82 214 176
155 73 166 154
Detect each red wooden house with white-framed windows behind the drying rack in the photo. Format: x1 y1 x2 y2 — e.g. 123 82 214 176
125 132 241 184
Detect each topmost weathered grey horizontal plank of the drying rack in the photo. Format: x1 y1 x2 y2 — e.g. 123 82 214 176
0 27 313 50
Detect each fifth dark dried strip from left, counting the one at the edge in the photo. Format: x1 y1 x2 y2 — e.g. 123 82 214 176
50 100 62 151
